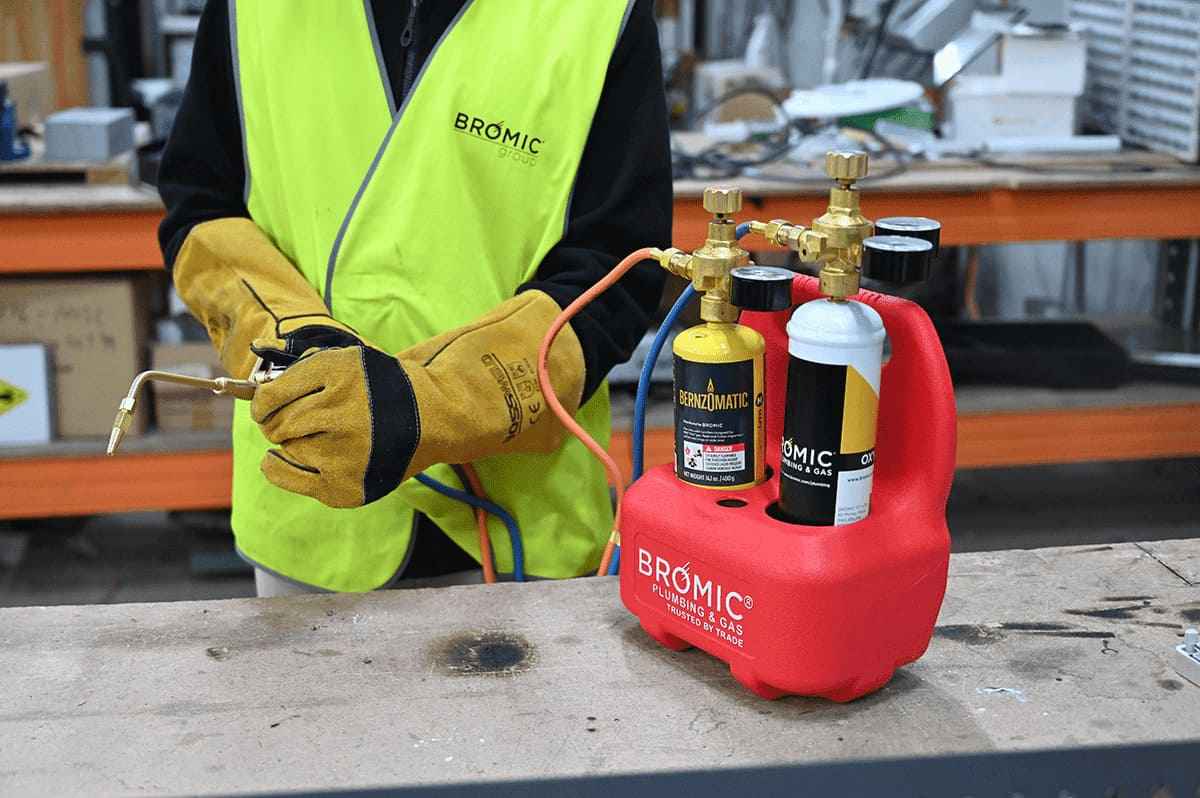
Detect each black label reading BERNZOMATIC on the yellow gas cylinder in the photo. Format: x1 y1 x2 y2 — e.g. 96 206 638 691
674 356 755 487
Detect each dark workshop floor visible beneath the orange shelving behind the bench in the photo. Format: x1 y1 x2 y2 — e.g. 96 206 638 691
0 460 1200 606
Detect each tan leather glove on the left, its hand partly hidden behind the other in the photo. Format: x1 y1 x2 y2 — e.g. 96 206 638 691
172 218 361 379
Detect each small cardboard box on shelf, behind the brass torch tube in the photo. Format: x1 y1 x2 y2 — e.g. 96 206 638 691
150 342 235 432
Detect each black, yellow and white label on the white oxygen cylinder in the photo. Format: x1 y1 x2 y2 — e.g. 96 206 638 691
779 356 878 526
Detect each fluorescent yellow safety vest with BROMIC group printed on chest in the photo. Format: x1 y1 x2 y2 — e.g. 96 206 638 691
229 0 632 590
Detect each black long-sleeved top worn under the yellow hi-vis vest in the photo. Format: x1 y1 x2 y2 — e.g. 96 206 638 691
158 0 671 397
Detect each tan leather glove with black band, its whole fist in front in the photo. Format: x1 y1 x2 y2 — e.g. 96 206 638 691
251 290 584 508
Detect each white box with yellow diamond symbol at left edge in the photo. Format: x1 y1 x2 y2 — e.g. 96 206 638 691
0 343 54 446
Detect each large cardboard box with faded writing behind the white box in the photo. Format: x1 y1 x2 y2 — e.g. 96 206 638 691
0 277 150 438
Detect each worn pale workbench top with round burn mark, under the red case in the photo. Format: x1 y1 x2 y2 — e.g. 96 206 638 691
0 541 1200 794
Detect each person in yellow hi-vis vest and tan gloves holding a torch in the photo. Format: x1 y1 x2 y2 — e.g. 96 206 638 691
160 0 672 595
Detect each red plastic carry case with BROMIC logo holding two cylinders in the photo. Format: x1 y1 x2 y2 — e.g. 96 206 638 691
620 277 955 701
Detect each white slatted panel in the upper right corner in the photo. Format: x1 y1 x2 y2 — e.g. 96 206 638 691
1070 0 1200 161
